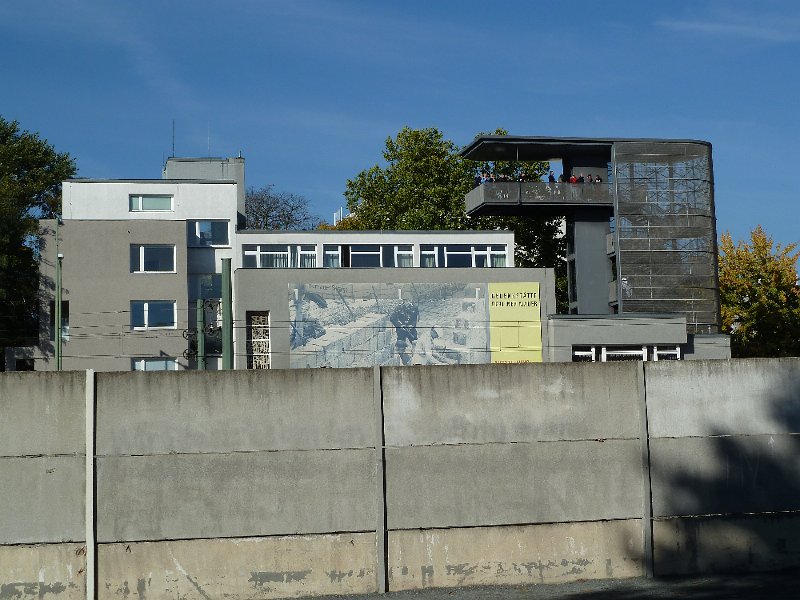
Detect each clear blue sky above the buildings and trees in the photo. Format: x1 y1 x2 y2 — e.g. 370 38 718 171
0 0 800 244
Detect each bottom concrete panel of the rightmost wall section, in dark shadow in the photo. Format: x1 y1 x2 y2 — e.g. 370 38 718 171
653 513 800 575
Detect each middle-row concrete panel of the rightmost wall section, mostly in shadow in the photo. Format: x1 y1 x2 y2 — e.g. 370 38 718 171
650 435 800 517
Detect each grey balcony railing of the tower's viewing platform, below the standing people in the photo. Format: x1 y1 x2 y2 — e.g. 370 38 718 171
465 181 614 213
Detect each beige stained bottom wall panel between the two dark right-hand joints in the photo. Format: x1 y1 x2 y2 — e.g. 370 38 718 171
389 520 643 591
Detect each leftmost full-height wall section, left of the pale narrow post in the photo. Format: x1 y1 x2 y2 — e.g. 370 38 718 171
0 372 86 600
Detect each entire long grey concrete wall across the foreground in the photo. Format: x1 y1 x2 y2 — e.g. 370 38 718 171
0 359 800 599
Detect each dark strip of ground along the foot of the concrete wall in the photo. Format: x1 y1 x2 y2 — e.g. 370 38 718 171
332 569 800 600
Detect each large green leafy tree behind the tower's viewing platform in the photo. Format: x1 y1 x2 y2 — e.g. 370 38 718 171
344 127 566 302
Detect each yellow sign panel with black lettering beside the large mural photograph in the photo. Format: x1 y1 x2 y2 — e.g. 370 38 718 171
488 282 542 363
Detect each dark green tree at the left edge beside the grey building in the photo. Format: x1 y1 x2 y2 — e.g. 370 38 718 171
0 117 75 352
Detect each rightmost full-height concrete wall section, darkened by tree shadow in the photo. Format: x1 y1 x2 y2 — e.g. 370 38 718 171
620 359 800 584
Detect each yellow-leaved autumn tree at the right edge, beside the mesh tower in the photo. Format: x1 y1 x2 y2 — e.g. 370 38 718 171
719 225 800 358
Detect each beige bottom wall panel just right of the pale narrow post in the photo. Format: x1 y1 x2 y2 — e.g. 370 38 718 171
98 533 376 600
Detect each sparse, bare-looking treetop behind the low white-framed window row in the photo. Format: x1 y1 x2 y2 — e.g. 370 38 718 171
245 185 322 230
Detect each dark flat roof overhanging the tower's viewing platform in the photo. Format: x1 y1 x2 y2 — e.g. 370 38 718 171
461 135 711 161
